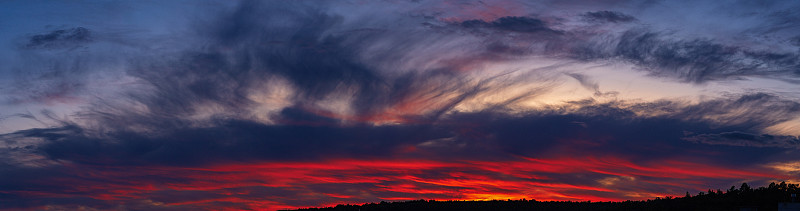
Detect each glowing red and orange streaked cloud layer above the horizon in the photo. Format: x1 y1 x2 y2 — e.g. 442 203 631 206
3 157 787 209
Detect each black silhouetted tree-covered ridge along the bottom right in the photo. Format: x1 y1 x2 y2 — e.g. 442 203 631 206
299 182 800 211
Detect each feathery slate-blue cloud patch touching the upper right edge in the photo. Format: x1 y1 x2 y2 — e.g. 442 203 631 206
611 31 800 83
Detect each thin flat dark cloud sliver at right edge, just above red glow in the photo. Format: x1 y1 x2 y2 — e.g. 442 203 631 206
684 131 800 149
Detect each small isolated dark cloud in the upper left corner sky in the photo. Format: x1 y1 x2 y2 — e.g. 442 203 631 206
25 27 92 49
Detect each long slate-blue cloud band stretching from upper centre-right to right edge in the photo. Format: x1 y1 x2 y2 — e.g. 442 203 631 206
444 15 800 83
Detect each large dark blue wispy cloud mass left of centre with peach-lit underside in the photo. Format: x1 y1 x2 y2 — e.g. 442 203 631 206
102 4 564 129
